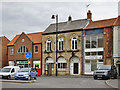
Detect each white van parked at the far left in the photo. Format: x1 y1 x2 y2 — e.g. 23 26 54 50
0 66 20 79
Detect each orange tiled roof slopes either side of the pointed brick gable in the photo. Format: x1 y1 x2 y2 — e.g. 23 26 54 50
8 32 42 46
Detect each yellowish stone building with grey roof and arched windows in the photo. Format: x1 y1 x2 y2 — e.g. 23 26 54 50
42 12 91 75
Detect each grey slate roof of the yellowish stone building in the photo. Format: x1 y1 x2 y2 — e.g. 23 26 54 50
43 19 88 34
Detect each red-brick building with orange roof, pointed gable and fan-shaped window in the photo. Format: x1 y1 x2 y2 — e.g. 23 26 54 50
7 32 42 68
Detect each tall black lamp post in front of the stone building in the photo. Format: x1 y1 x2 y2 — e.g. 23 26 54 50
51 14 58 76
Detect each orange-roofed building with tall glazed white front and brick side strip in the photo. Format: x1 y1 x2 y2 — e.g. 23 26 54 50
84 15 117 74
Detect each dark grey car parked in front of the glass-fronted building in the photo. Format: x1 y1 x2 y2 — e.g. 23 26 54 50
93 65 117 79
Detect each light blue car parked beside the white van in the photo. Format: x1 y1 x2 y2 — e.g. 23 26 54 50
15 67 37 80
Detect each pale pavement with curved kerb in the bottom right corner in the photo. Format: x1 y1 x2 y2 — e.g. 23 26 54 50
105 78 120 90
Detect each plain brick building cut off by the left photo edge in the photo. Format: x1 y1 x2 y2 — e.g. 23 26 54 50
0 36 10 68
